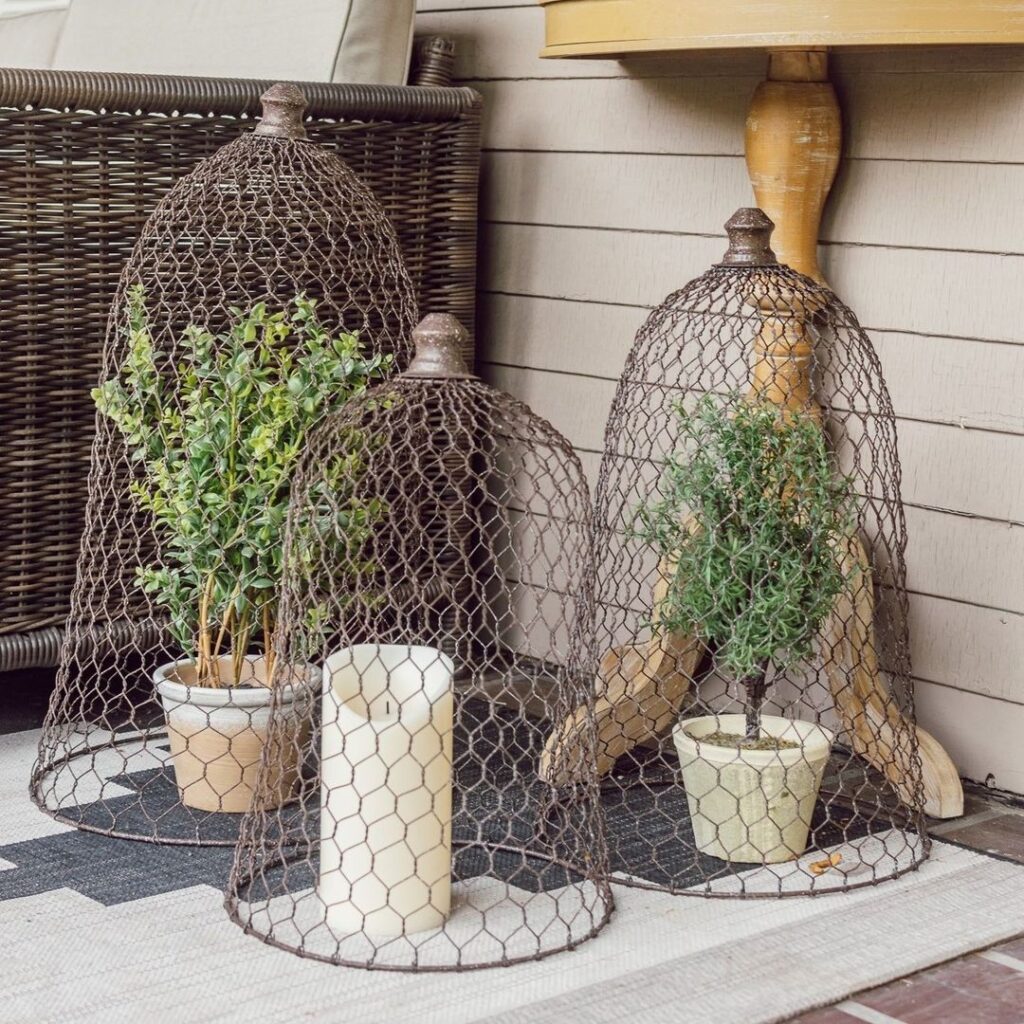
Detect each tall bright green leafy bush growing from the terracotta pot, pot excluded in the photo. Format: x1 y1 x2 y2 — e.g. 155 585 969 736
92 289 390 686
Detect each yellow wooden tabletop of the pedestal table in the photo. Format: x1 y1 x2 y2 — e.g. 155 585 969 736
540 0 1024 57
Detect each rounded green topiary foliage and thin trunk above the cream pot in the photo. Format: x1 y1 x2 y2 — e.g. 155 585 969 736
637 395 856 743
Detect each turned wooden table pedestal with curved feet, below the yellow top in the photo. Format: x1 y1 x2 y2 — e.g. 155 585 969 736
541 50 964 817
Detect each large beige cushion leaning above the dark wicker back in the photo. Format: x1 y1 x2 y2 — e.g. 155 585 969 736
53 0 416 85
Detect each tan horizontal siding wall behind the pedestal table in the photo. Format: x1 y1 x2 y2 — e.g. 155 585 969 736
418 0 1024 792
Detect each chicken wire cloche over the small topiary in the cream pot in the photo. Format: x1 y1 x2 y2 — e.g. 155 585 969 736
545 210 933 896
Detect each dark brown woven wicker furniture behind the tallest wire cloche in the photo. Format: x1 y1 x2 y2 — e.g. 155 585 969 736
0 54 480 672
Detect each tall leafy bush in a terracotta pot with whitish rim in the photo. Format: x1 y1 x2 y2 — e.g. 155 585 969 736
93 290 390 811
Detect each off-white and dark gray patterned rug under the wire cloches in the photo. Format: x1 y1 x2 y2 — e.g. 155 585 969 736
6 731 1024 1024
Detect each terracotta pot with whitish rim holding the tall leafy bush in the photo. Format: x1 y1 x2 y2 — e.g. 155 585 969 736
154 655 316 813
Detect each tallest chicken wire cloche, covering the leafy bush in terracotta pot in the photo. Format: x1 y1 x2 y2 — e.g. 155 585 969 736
32 85 416 845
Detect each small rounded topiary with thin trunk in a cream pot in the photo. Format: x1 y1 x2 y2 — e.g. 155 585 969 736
638 395 855 863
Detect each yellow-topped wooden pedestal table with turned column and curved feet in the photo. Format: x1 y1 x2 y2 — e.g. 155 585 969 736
540 0 983 817
